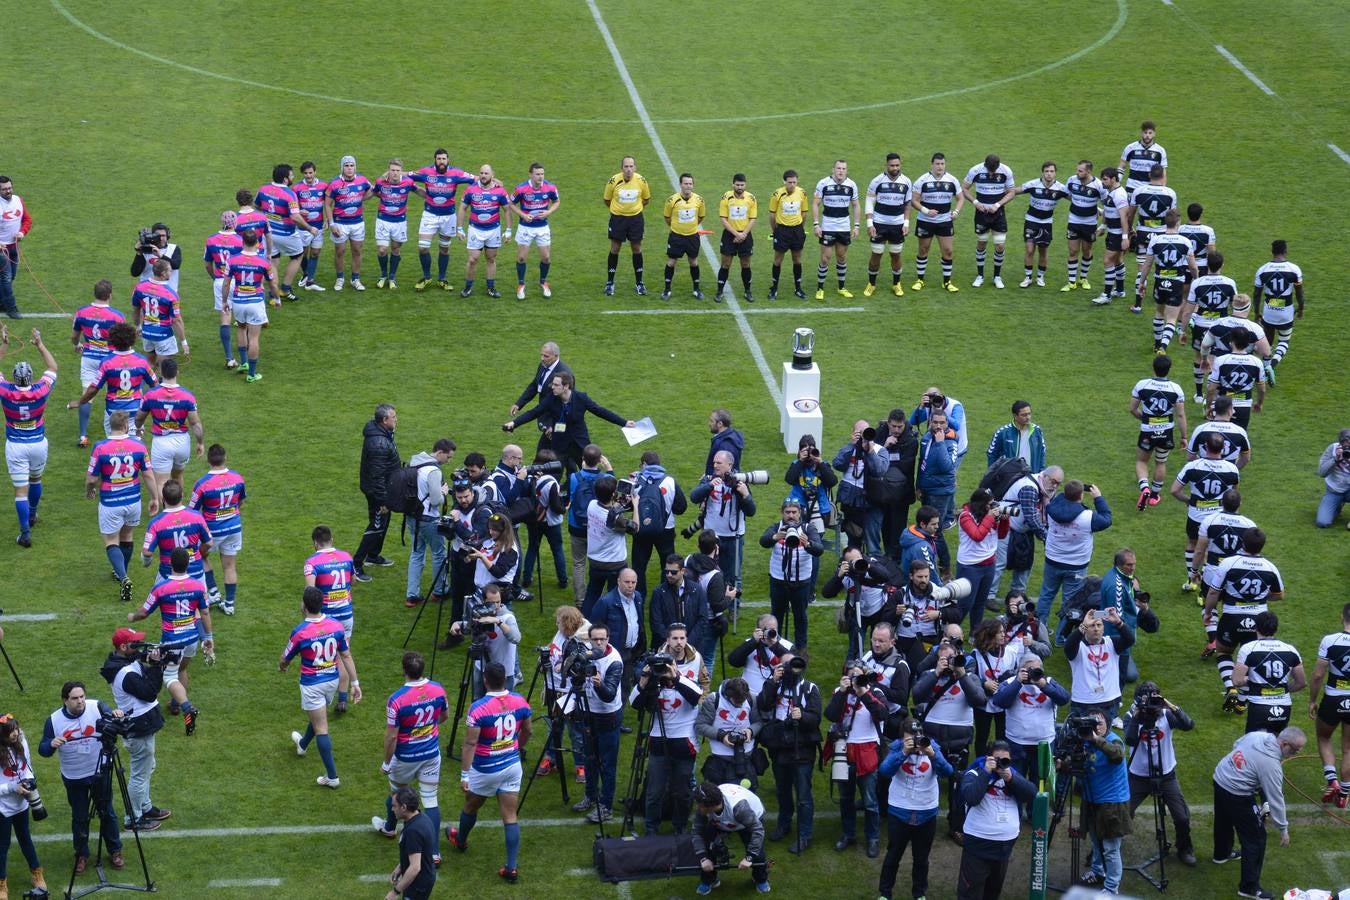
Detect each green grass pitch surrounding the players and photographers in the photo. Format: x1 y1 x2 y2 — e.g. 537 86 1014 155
0 0 1350 899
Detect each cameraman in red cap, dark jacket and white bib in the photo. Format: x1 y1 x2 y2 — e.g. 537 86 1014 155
99 627 173 831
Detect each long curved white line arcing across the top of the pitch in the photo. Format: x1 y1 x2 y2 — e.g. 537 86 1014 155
51 0 1129 125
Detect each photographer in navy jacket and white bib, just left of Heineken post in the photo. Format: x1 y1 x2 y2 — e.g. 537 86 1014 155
879 719 953 900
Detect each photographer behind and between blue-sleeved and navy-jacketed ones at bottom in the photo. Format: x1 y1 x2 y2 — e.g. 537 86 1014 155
911 641 988 843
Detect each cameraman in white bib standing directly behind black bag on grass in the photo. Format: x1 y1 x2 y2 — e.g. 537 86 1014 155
628 639 703 835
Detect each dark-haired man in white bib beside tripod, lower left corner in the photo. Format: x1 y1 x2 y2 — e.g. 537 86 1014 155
38 681 127 874
